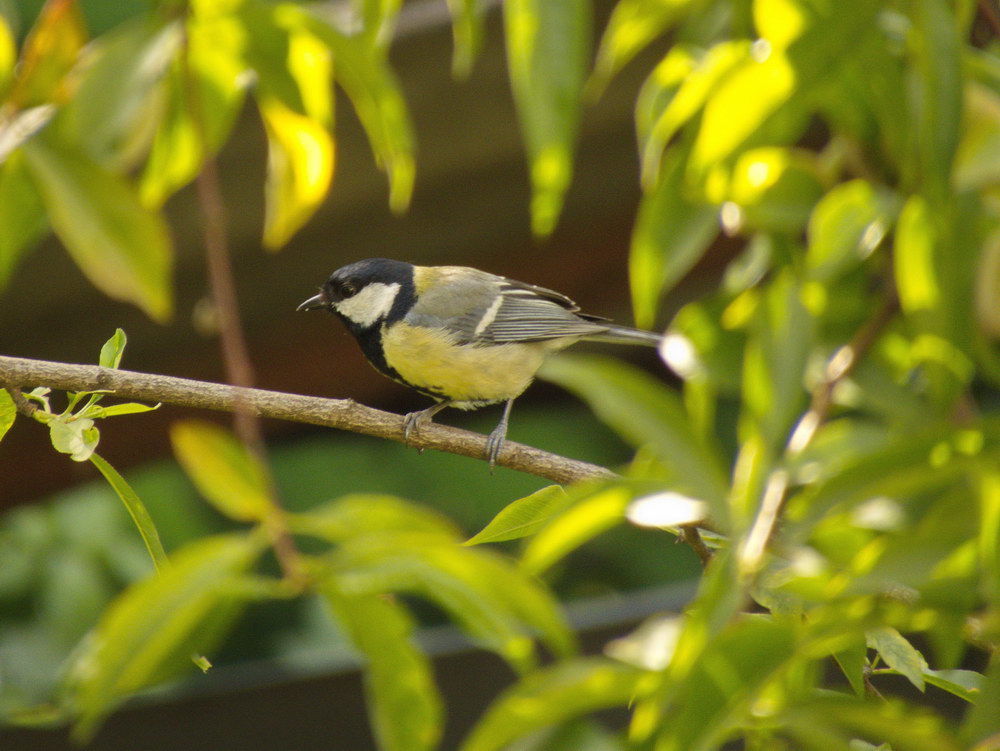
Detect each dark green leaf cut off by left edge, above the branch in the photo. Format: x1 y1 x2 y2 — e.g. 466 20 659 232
0 151 48 290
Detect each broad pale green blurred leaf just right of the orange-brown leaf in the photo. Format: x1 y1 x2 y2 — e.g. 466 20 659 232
58 17 182 170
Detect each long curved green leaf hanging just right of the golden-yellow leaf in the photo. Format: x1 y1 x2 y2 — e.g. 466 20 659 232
304 9 415 212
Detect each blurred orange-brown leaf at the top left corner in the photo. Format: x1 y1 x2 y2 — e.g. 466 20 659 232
9 0 87 109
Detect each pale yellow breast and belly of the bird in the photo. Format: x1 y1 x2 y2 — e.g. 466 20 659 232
382 322 575 407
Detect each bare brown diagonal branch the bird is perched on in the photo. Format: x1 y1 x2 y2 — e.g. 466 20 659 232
0 355 616 484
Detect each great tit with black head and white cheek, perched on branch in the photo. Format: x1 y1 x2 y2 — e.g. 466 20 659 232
298 258 661 467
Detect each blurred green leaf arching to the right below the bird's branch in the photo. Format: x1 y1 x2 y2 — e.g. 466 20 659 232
331 533 573 670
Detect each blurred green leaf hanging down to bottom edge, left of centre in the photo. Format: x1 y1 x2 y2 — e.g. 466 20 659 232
320 579 444 751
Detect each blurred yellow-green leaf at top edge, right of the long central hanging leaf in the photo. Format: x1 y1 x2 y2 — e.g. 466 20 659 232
587 0 699 94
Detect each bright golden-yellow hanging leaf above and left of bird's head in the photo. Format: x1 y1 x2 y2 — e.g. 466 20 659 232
258 99 334 250
